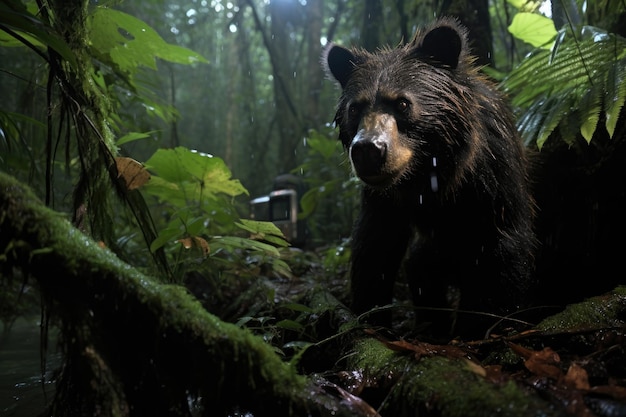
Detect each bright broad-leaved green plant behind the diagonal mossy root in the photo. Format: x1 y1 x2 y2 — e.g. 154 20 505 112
142 147 289 279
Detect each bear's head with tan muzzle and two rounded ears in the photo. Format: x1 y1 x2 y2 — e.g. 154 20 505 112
322 18 475 191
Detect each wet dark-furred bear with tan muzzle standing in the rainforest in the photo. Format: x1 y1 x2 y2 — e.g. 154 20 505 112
322 17 536 337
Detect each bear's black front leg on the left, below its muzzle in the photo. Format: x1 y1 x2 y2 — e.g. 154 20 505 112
350 189 411 326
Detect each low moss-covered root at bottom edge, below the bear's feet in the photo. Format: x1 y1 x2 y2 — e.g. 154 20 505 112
350 339 556 417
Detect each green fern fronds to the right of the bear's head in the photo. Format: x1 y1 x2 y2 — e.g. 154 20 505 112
502 26 626 149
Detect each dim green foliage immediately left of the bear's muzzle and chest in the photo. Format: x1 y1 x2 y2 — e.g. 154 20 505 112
293 128 360 244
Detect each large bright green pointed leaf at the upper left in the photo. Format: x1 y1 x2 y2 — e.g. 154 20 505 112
87 6 207 74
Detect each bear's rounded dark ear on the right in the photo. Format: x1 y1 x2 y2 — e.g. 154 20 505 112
418 25 465 69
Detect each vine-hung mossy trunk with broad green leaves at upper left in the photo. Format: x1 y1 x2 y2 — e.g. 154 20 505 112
0 0 213 275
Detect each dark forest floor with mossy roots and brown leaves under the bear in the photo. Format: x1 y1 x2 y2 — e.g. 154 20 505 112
222 247 626 417
